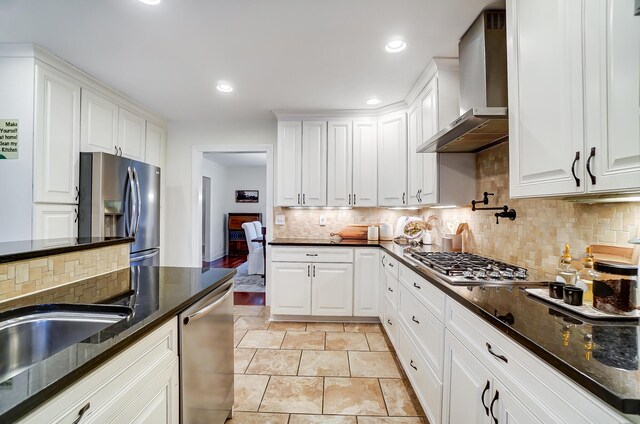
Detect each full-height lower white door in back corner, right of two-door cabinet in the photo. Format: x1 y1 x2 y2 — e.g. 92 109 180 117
353 249 380 317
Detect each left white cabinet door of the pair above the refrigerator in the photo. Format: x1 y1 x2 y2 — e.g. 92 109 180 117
80 88 118 155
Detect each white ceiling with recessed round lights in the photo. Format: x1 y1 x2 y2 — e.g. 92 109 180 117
0 0 495 121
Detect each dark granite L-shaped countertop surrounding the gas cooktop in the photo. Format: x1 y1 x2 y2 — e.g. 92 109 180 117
270 239 640 415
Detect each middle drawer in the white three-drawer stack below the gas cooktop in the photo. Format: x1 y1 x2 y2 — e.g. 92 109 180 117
398 284 444 379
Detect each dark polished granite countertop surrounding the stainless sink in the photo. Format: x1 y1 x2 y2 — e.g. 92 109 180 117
0 267 236 422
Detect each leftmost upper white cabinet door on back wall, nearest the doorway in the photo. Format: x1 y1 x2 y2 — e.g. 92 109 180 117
276 121 302 206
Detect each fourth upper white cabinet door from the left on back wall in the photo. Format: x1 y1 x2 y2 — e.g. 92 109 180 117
352 121 378 207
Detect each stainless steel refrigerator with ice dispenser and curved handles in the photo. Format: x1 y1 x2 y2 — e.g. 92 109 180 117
78 153 160 265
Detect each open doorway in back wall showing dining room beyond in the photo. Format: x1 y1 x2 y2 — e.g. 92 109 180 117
192 145 273 305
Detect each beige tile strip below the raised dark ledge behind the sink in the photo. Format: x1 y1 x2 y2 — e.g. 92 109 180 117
0 243 129 302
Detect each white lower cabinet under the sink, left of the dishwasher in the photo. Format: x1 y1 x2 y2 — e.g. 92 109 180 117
20 319 180 424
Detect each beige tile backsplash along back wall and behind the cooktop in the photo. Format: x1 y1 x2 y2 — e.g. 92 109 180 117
273 143 640 278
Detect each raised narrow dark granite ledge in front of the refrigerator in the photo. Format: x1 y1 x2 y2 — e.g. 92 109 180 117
0 237 135 263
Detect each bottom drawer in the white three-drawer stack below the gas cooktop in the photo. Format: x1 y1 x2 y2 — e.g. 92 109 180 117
396 322 442 423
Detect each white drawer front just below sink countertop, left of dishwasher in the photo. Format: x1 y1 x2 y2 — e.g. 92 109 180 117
21 319 178 424
